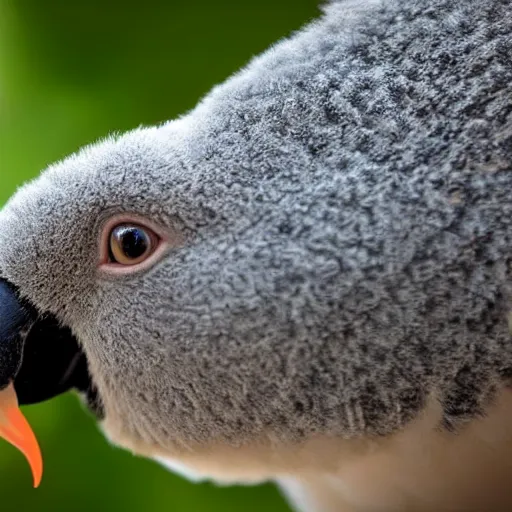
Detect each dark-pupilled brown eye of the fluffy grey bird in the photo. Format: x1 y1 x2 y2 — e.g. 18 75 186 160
109 224 158 265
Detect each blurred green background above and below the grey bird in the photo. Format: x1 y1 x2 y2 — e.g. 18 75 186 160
0 0 319 512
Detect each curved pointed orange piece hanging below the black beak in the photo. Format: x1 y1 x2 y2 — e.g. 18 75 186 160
0 384 43 487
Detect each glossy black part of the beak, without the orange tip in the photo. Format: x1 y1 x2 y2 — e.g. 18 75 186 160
0 279 102 416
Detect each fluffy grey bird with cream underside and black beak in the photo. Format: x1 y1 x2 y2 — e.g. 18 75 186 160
0 0 512 512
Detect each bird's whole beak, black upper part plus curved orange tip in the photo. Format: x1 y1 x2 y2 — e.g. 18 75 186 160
0 279 101 487
